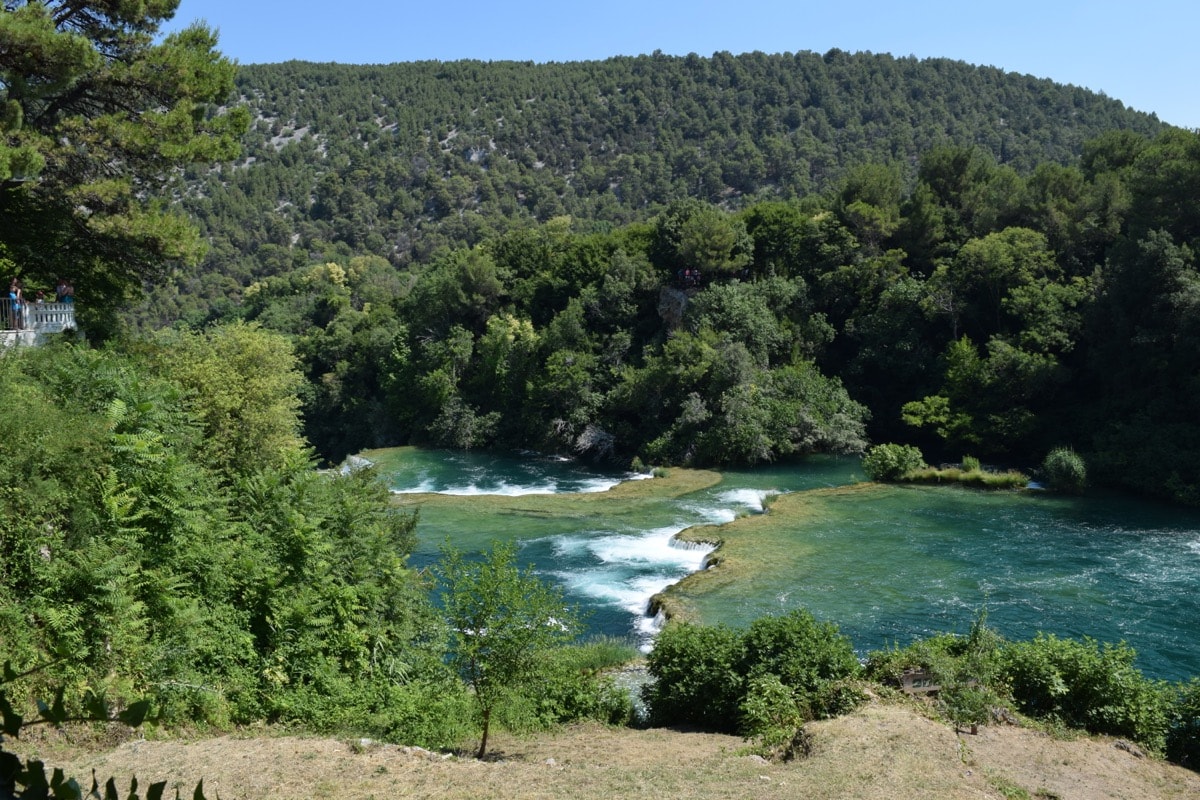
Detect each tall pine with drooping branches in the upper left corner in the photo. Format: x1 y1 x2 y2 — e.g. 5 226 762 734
0 0 250 332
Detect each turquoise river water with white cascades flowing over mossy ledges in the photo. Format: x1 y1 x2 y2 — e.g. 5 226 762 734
368 449 1200 680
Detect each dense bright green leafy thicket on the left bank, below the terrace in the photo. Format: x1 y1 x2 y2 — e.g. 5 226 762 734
0 329 445 730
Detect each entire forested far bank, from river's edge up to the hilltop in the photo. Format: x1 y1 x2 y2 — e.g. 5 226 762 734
112 52 1198 503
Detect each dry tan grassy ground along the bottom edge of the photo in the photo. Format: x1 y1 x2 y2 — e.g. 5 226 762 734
16 700 1200 800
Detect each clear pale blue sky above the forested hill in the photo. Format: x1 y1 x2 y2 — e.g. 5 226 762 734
168 0 1200 128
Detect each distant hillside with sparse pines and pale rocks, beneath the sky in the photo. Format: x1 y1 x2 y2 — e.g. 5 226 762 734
144 50 1162 324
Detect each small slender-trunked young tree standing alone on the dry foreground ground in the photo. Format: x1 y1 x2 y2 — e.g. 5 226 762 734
438 542 577 758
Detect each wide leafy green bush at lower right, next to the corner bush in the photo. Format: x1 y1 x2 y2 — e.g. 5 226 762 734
1001 633 1168 752
